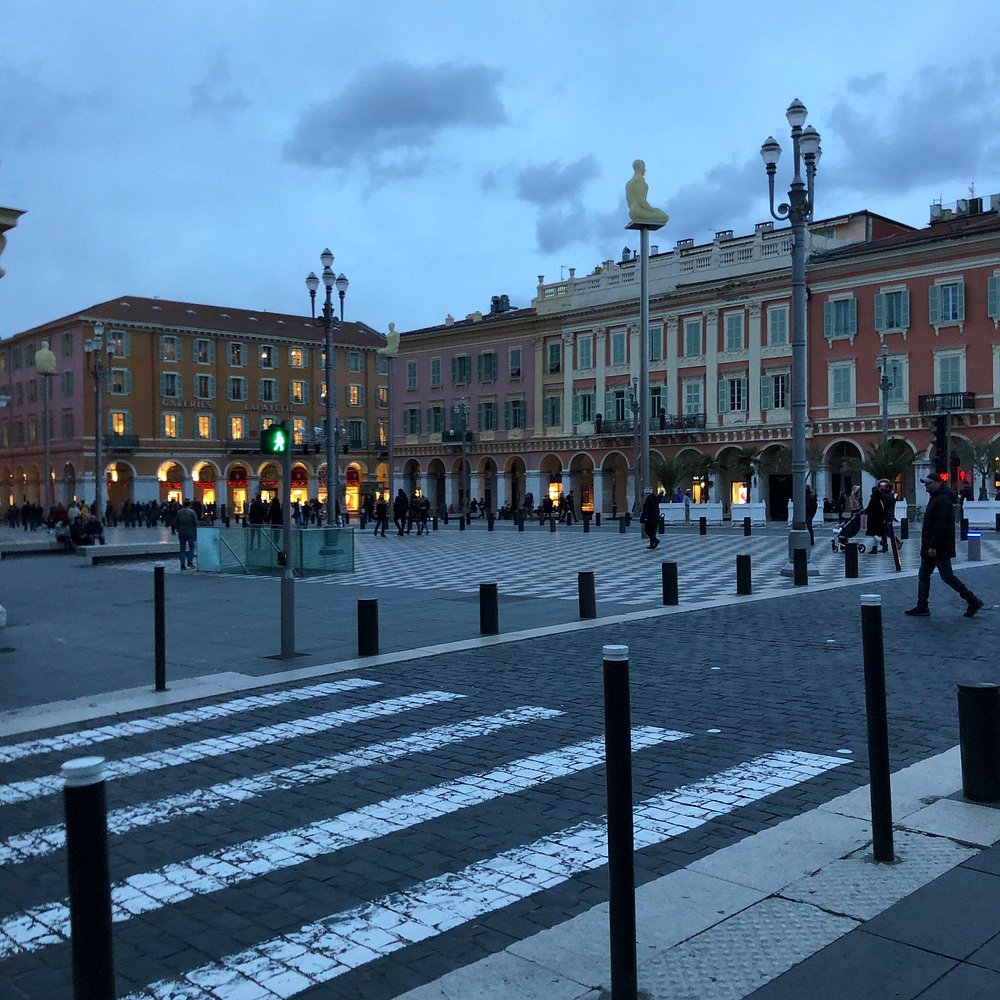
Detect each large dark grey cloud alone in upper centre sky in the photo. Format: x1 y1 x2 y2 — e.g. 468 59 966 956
285 62 507 178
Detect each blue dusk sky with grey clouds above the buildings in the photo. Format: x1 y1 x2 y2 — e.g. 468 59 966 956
0 0 1000 336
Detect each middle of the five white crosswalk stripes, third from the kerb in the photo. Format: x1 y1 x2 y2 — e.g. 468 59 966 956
0 706 562 865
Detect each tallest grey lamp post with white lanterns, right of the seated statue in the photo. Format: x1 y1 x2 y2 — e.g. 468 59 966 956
760 100 821 582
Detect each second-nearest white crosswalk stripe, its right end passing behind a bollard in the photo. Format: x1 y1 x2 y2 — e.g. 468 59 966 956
0 727 689 958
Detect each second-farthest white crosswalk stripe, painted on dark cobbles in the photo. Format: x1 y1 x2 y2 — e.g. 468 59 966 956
0 691 465 805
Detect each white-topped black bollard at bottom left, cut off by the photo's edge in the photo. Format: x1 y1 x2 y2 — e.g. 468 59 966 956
62 757 115 1000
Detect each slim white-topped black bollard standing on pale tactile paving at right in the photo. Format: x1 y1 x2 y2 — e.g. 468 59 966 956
861 594 895 863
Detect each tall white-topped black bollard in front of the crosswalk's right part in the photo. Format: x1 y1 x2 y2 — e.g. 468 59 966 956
604 645 638 1000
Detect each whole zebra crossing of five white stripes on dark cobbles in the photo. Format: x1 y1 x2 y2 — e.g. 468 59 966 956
0 678 848 1000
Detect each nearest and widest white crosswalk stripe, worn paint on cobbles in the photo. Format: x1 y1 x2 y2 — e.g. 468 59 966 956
126 751 845 1000
